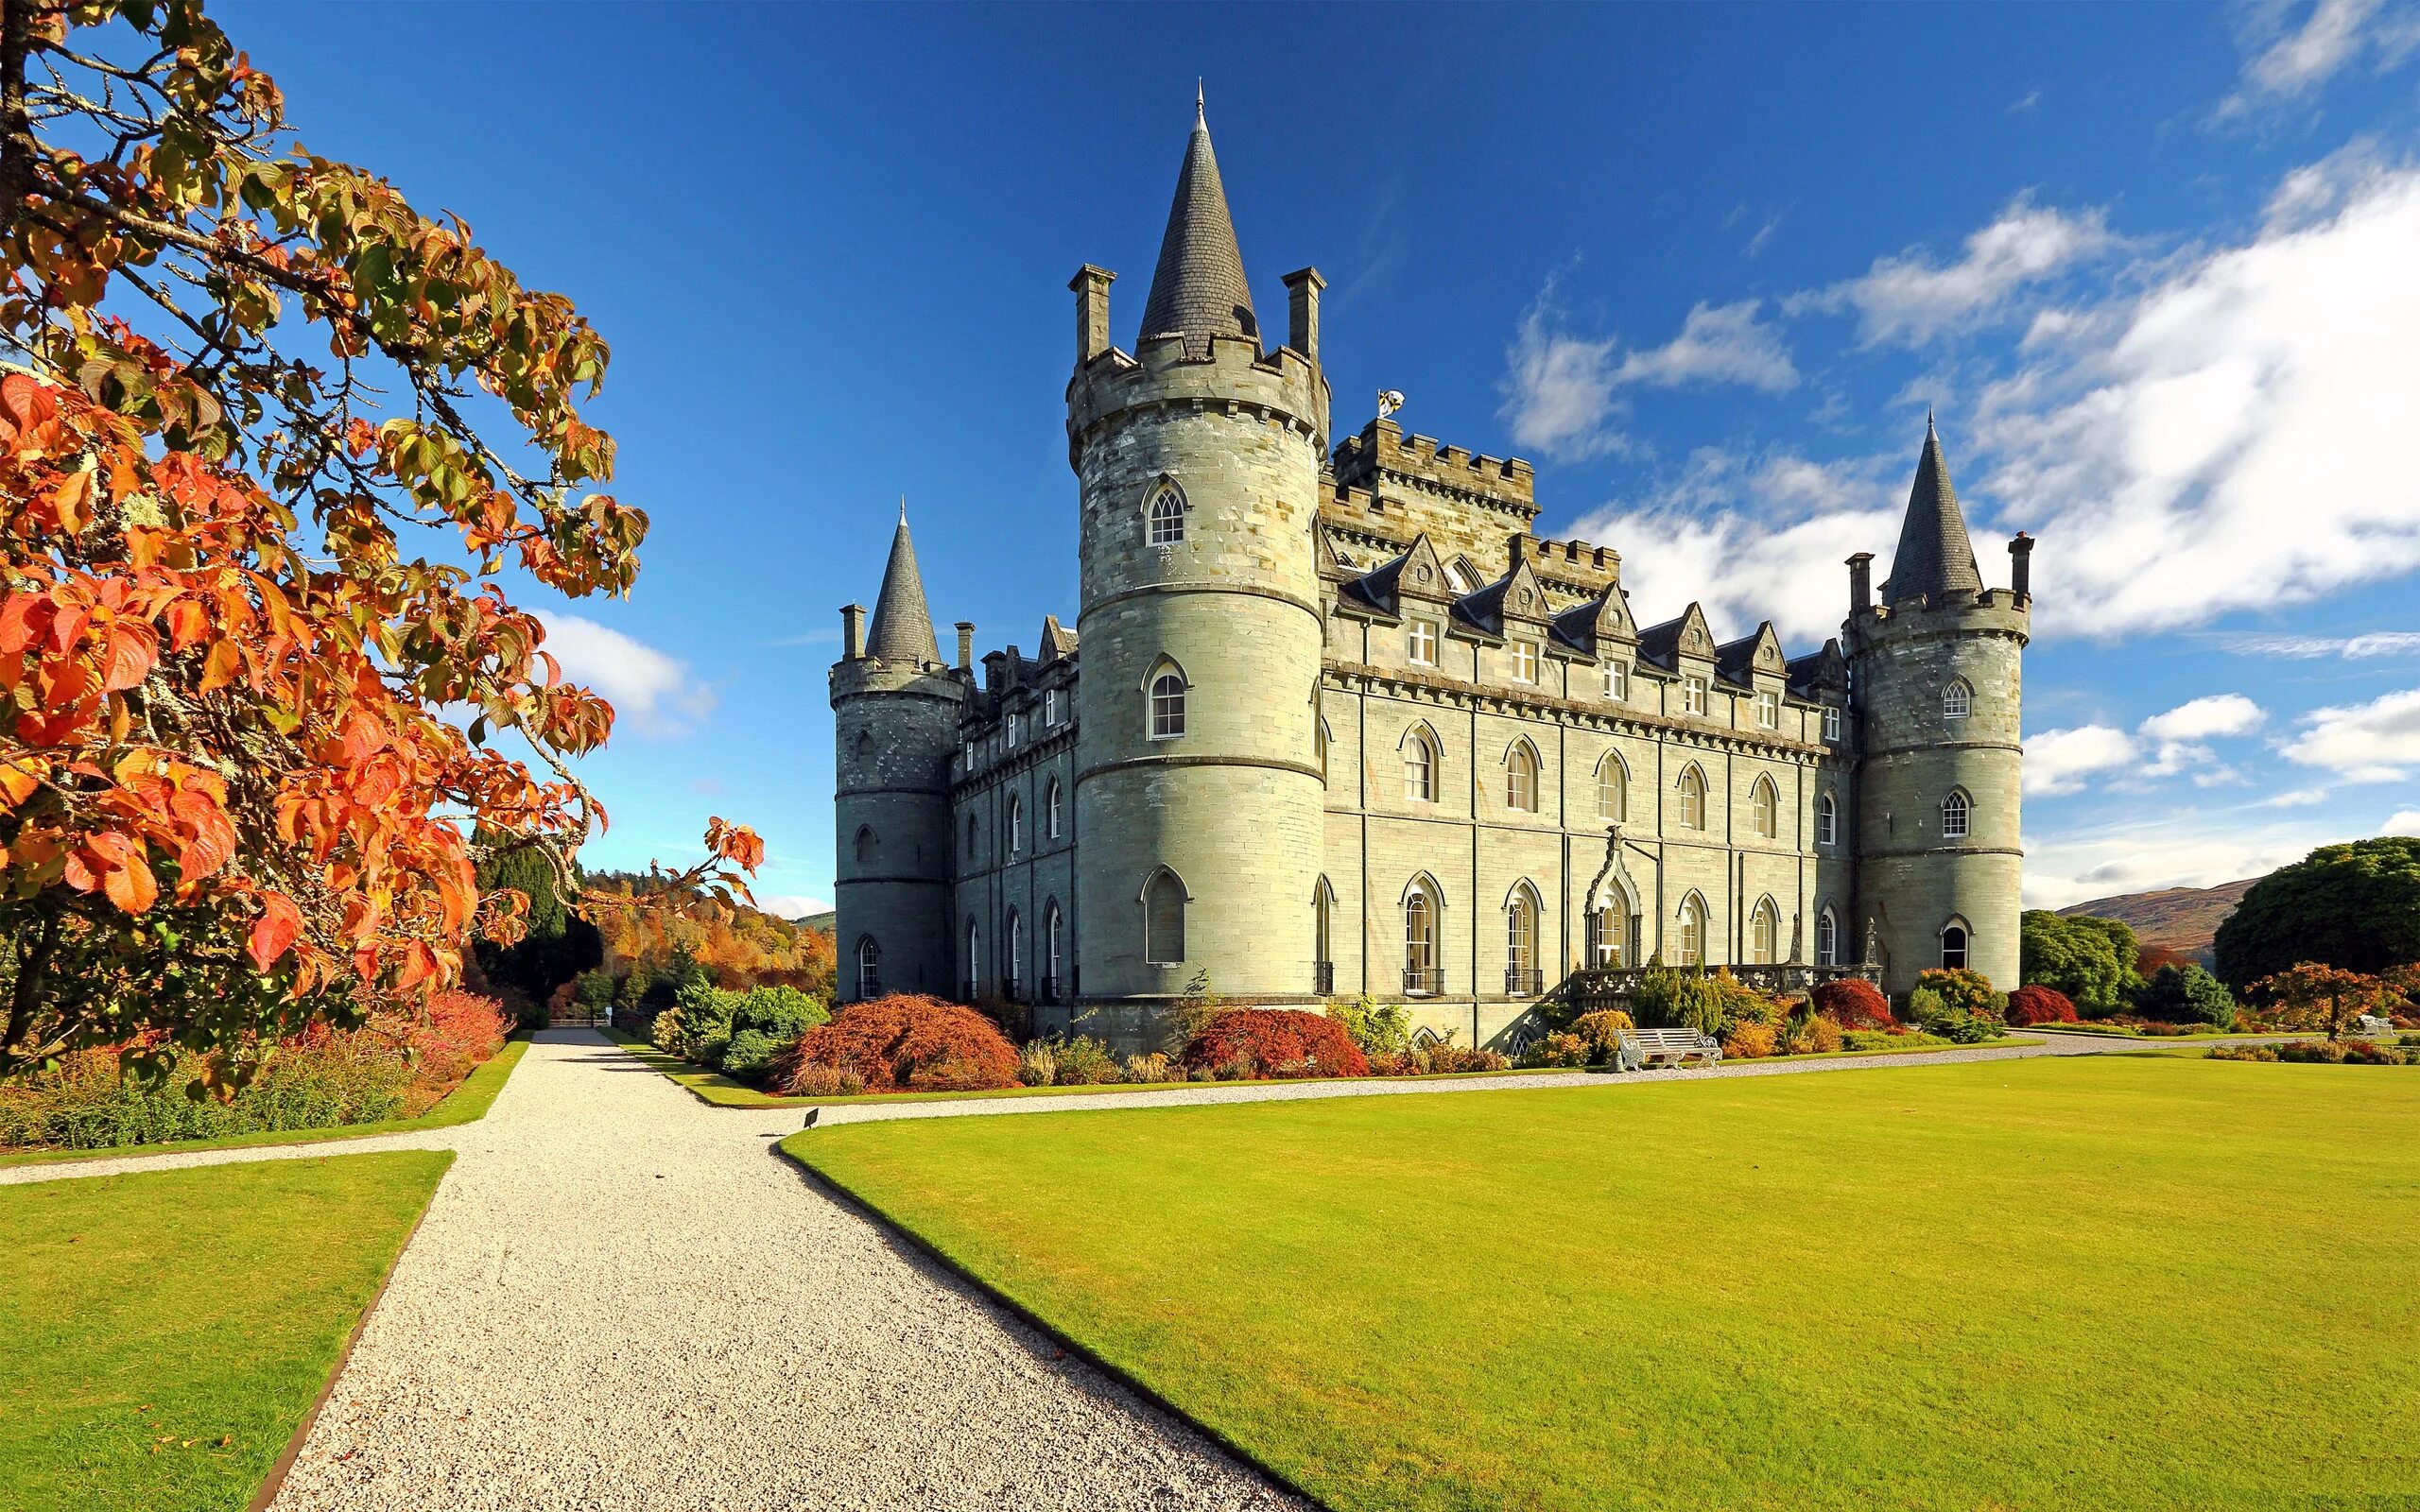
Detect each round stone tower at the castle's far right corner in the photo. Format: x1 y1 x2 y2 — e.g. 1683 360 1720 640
1844 421 2032 994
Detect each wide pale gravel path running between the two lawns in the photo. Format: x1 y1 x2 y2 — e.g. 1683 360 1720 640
265 1031 1295 1512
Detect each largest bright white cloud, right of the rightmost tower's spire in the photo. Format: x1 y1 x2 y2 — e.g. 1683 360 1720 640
1978 164 2420 636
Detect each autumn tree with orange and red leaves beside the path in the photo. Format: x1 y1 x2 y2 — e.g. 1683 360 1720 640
0 0 762 1086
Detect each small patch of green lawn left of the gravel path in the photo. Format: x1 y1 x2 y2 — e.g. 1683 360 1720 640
0 1149 453 1512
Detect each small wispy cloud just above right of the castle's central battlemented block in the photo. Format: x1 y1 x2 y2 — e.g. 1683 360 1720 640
1500 281 1798 459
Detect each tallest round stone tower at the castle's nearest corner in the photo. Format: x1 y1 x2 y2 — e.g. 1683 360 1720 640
1067 100 1328 1005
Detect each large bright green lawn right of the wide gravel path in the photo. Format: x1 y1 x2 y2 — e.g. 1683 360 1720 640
784 1057 2420 1509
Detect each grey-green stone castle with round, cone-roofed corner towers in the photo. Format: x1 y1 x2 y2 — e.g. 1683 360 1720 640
830 97 2032 1042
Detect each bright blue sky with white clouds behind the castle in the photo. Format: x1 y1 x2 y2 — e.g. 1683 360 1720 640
217 0 2420 910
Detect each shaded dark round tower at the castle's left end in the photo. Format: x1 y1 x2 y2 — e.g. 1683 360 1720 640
830 503 965 1002
